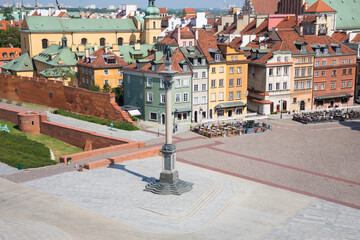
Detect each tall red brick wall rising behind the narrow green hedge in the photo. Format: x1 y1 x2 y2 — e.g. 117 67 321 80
0 74 134 123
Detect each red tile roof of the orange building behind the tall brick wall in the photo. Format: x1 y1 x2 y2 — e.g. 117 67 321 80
78 47 127 68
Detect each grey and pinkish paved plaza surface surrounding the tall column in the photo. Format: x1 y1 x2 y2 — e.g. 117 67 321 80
0 102 360 240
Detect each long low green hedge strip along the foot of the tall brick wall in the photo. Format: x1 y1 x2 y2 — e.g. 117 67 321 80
54 109 139 131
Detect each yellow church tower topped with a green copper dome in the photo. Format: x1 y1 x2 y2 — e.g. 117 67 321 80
142 0 161 44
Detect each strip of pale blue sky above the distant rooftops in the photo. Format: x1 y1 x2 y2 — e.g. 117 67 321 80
35 0 243 8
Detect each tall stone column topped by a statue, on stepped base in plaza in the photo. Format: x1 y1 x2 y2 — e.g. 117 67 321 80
144 46 193 195
